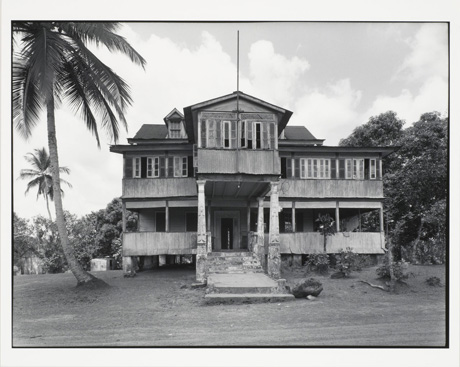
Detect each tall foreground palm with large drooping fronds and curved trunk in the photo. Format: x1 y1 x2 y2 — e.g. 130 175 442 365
12 22 145 285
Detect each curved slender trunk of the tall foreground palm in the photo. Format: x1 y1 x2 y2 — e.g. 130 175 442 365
46 92 94 285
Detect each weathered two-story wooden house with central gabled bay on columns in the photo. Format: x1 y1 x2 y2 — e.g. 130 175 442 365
110 92 393 281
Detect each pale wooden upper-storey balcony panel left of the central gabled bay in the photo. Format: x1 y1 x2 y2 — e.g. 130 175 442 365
123 177 197 199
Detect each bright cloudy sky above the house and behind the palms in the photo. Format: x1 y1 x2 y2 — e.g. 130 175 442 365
13 22 448 218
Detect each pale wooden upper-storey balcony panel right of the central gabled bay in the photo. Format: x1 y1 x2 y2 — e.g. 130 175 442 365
280 179 383 199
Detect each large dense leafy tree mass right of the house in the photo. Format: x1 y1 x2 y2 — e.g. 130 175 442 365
340 111 448 261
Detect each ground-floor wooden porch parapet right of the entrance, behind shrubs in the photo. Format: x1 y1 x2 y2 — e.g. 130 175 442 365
280 232 385 254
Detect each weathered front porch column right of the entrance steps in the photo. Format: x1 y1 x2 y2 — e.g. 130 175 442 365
267 182 281 279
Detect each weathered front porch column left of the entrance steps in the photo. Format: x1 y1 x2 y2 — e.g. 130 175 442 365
196 180 208 282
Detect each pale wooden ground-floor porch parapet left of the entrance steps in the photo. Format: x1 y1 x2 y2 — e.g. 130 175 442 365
123 232 197 256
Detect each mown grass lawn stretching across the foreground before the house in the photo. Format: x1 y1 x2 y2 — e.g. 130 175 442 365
13 265 446 347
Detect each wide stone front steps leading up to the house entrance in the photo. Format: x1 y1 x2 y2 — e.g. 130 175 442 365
205 252 294 303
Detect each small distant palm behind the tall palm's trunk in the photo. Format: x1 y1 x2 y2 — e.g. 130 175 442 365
19 148 72 221
